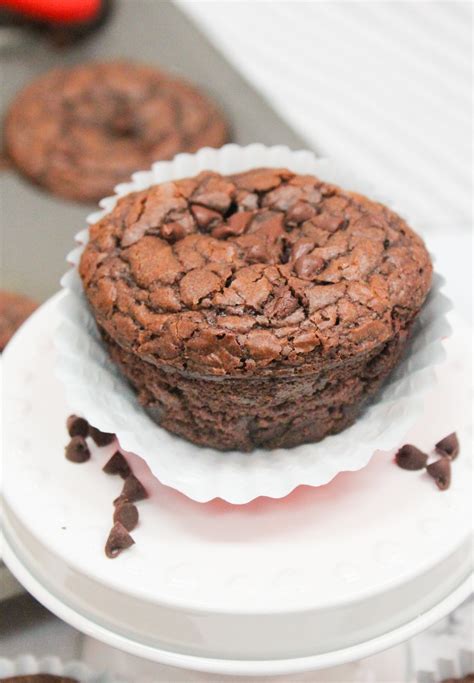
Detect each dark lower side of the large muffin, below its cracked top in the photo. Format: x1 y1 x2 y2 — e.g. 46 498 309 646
103 329 409 451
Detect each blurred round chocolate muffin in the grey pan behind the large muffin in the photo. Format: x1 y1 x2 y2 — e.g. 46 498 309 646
5 62 227 202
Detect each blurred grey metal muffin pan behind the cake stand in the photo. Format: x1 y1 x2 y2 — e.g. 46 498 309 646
0 0 307 301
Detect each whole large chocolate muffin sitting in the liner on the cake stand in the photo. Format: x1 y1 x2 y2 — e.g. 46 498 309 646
80 169 432 451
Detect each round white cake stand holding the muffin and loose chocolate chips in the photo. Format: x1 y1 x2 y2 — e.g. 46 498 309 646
3 298 472 675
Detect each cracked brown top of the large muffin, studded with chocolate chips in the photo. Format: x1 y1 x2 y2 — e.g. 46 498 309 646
80 169 432 375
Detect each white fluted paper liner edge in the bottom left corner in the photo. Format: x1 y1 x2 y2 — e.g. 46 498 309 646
0 654 125 683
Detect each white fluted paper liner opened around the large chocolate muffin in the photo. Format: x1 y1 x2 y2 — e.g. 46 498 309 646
56 144 451 504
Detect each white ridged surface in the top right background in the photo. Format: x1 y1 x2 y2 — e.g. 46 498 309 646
178 0 472 230
